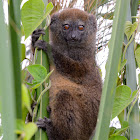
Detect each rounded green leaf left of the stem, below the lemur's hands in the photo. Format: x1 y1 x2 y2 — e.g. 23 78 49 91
27 64 47 82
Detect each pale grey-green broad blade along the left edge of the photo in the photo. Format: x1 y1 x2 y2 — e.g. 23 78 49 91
0 1 16 140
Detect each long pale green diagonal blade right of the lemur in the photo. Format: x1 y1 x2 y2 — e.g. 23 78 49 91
95 0 130 140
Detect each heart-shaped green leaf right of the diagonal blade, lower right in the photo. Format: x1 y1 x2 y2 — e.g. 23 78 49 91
112 85 137 119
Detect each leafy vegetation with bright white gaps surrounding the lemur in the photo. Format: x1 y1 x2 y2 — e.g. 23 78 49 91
0 0 140 140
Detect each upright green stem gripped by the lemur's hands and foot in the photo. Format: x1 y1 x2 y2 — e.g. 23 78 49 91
35 0 49 140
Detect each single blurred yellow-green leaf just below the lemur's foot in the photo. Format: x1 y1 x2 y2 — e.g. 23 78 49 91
23 123 38 140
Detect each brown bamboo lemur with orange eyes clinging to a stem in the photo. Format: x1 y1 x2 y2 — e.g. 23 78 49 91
32 9 102 140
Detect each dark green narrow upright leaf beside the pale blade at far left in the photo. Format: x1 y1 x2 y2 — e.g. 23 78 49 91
9 0 22 118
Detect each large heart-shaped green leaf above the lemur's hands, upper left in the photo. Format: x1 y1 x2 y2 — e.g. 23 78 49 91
21 0 53 38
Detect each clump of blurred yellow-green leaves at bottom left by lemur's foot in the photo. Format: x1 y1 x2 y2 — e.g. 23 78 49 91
15 120 38 140
